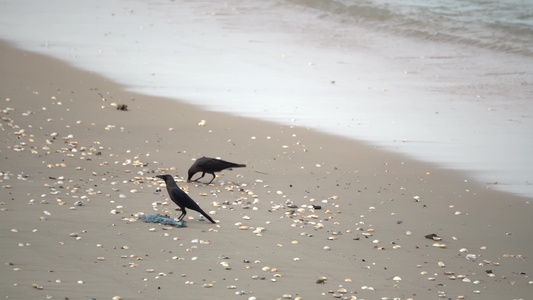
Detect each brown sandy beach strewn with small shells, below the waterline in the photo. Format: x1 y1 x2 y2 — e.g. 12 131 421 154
0 43 533 299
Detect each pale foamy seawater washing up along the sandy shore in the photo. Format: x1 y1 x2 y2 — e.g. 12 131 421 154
0 0 533 198
